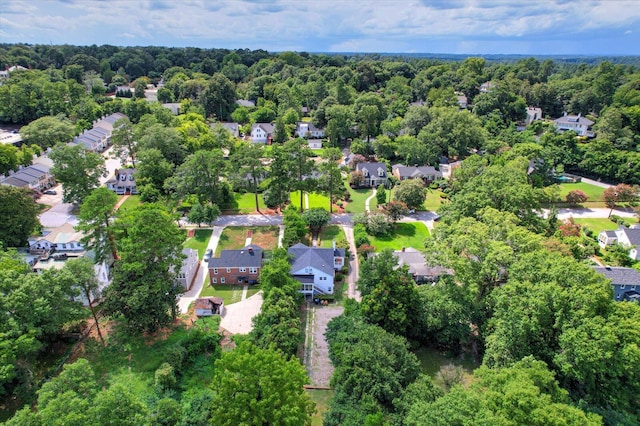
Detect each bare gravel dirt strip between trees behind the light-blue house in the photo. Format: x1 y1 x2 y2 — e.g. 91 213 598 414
305 305 344 386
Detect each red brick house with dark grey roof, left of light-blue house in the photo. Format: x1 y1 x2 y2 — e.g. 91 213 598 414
209 244 264 285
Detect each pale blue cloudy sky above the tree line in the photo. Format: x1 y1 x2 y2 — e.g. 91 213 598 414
0 0 640 55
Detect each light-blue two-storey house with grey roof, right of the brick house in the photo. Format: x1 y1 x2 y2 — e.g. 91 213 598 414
288 242 345 296
